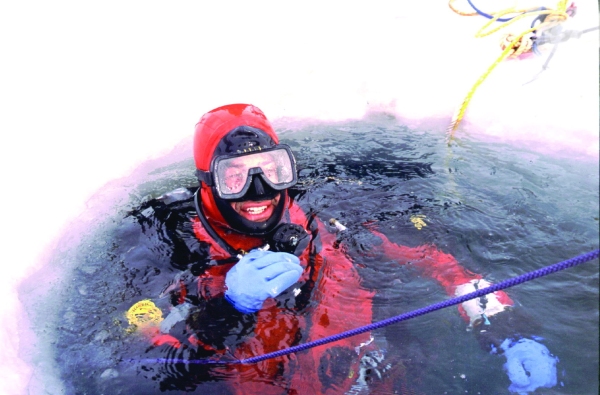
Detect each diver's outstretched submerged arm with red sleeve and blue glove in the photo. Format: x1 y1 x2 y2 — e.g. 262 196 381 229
371 229 558 393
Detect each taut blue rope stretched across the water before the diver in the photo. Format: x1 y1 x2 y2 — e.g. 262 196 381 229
137 250 600 365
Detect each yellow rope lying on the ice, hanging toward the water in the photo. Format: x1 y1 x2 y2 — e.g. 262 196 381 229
447 0 568 142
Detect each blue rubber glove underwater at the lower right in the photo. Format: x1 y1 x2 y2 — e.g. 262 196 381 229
500 339 558 393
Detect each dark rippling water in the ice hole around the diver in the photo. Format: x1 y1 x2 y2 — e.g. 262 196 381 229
21 116 599 395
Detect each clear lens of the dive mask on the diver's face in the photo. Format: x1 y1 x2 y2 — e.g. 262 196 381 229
213 148 296 198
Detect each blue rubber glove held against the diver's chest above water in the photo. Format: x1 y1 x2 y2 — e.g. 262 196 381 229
225 250 303 313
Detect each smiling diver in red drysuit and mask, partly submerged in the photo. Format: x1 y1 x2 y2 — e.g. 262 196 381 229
129 104 556 395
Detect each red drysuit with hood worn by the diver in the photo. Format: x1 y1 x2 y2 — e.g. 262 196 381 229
138 105 511 395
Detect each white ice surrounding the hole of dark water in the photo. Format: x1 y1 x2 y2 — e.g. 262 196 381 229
0 0 599 395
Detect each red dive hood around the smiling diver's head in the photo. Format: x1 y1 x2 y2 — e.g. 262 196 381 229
194 104 289 249
